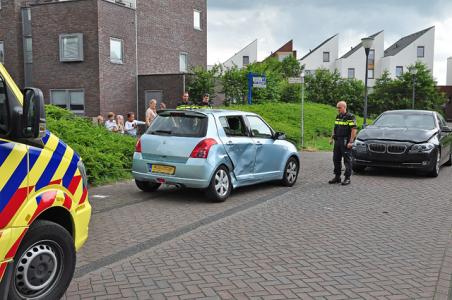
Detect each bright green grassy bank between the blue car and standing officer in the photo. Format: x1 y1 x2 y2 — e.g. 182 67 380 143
227 102 363 151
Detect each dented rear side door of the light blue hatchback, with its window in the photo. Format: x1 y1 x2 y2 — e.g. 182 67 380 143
218 115 256 181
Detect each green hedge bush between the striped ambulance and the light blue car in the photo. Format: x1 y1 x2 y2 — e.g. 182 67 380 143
46 105 136 185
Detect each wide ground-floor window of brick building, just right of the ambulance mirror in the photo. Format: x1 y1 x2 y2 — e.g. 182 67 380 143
50 89 85 113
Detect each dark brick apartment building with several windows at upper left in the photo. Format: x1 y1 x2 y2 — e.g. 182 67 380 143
0 0 207 119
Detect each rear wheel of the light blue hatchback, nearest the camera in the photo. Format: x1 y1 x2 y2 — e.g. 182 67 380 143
206 166 232 202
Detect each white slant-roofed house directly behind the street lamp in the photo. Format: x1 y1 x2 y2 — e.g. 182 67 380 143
336 30 384 87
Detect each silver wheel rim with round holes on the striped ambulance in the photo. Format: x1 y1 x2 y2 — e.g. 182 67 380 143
14 241 62 299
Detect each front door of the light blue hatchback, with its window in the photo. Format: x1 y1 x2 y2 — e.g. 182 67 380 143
246 115 285 179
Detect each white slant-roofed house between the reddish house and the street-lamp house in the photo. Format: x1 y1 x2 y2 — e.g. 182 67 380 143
299 34 339 74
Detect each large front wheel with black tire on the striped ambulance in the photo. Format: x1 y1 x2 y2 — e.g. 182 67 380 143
8 220 76 300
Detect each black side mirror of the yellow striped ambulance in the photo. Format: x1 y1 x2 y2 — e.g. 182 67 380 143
21 88 46 139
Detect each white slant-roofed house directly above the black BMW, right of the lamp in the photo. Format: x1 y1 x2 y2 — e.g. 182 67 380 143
382 26 435 78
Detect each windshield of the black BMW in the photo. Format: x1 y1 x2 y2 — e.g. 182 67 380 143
374 113 436 130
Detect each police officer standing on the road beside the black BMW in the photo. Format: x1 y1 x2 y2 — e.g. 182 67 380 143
328 101 357 185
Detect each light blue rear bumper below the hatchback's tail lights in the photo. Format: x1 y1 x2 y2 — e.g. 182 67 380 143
132 153 215 189
